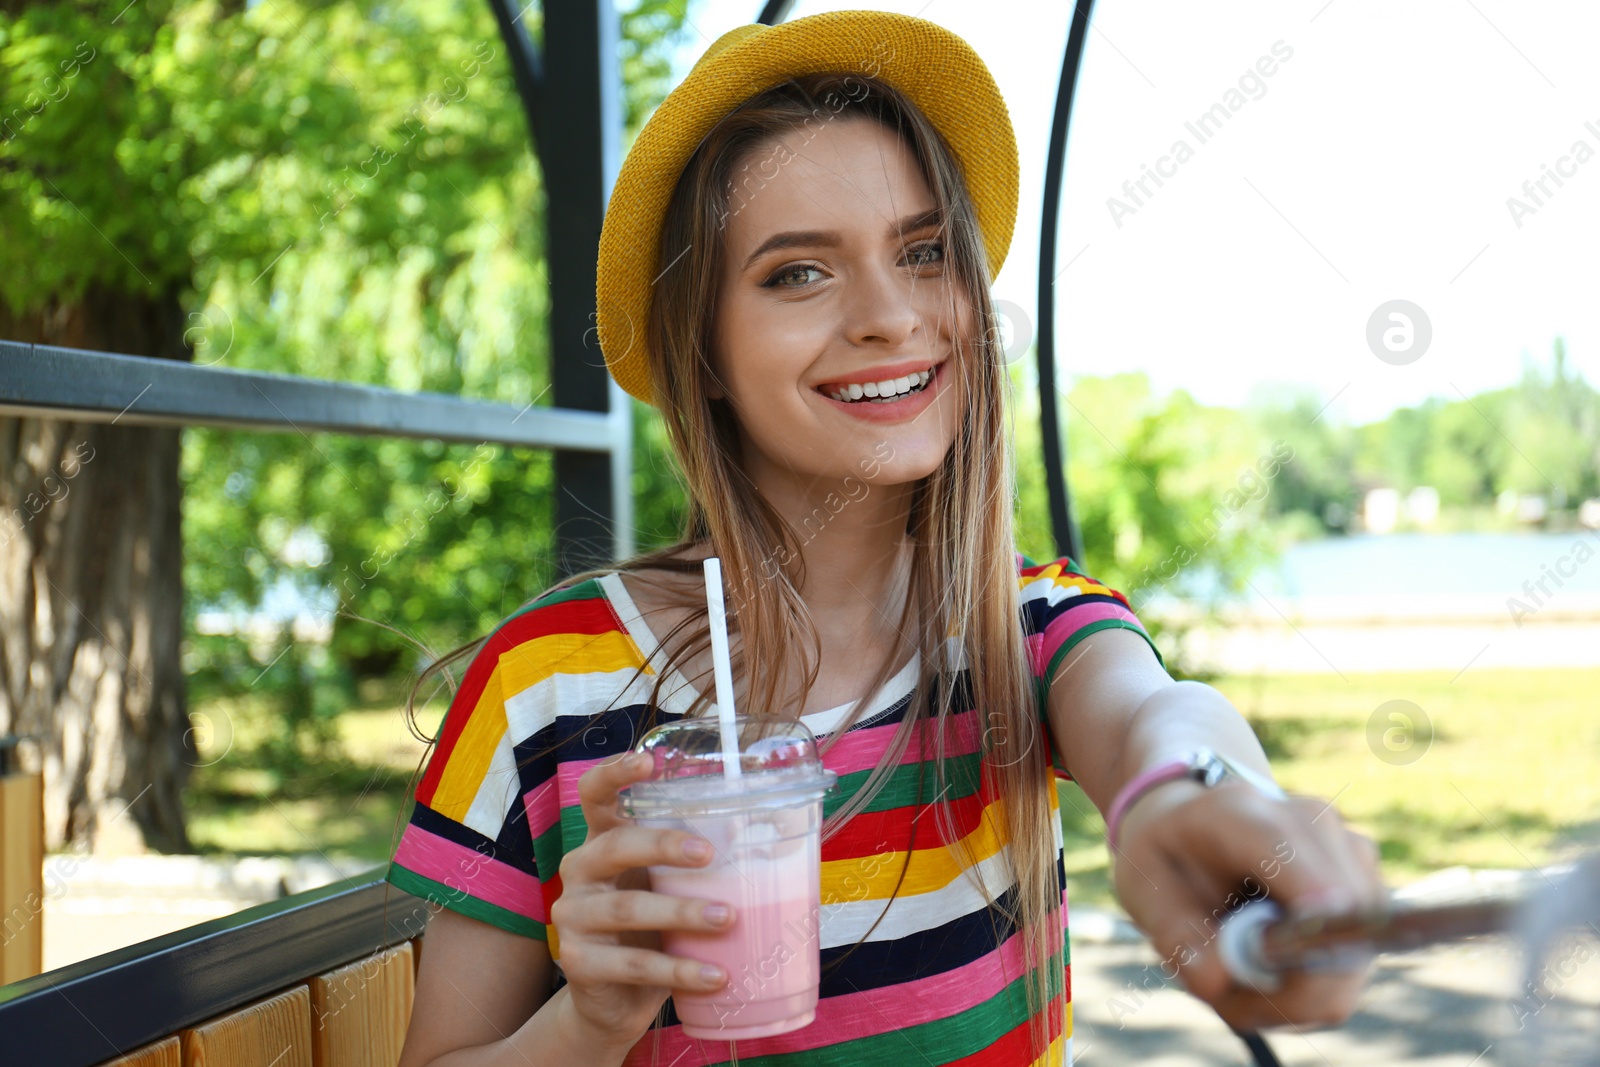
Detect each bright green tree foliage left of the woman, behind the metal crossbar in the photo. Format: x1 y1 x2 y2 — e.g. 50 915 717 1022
0 0 685 783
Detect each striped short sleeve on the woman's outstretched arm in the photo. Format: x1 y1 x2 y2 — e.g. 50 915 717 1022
1016 553 1166 779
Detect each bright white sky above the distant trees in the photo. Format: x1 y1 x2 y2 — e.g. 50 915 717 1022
652 0 1600 422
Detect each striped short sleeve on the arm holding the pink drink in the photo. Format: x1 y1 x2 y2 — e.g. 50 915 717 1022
387 621 557 941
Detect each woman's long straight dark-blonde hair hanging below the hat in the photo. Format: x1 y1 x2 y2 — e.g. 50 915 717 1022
408 74 1064 1059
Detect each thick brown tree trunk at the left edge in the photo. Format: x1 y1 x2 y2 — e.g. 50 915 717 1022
0 290 195 851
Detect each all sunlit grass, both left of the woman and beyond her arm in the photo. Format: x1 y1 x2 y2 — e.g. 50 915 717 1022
187 670 1600 905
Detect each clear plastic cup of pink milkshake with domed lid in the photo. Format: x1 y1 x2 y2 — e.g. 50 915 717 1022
621 717 837 1041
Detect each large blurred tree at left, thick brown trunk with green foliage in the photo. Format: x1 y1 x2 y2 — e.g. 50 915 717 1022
0 0 683 849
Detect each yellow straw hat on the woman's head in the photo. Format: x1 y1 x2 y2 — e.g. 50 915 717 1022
595 11 1018 403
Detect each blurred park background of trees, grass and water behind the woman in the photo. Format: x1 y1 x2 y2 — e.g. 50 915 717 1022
0 0 1600 1062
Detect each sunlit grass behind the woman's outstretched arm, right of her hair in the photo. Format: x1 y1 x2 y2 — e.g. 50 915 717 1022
1062 669 1600 905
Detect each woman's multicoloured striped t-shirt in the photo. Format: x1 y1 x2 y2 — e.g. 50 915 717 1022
389 555 1160 1067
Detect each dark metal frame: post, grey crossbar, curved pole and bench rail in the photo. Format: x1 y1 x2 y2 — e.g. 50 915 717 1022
0 0 1277 1067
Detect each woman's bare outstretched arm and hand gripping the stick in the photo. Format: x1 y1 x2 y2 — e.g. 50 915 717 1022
1048 629 1384 1029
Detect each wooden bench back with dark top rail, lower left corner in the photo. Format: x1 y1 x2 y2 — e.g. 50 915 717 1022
0 881 437 1067
